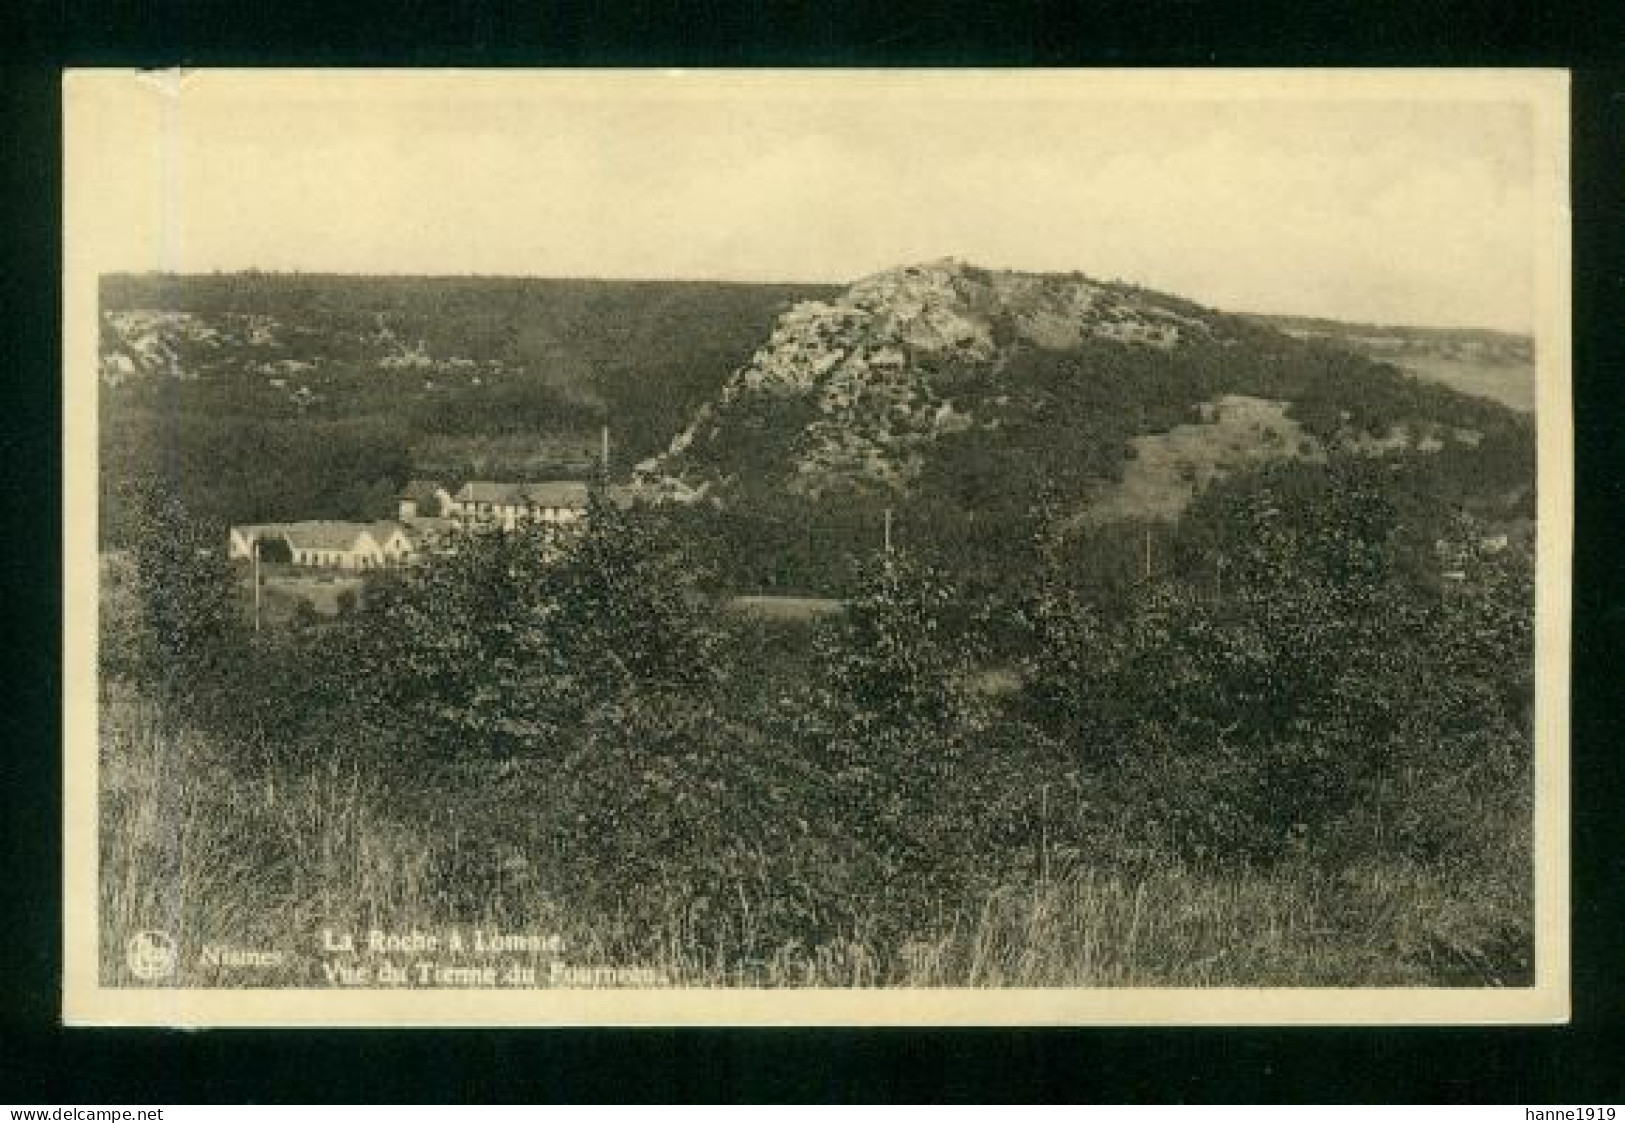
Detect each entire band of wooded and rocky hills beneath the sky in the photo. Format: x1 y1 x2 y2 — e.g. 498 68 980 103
99 260 1532 549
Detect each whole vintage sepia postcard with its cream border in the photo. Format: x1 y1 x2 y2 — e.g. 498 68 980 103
63 70 1571 1025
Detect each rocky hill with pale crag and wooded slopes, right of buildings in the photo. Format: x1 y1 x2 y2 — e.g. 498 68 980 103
639 260 1506 518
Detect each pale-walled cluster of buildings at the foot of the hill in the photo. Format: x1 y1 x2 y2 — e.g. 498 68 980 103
228 479 611 570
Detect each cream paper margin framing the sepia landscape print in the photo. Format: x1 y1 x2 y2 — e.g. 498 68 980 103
62 70 1573 1027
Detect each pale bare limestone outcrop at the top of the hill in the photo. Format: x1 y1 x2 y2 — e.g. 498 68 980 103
640 258 1212 497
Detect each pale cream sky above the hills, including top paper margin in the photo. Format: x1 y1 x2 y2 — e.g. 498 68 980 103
65 72 1552 330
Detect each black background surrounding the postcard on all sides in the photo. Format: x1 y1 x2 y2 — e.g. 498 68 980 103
0 0 1625 1105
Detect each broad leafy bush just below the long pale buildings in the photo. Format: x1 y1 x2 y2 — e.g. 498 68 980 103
330 502 722 757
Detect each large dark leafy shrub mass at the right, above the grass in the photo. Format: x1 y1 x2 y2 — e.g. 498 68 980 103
1025 465 1532 861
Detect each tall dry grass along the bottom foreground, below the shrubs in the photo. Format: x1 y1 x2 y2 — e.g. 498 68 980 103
101 700 1532 986
